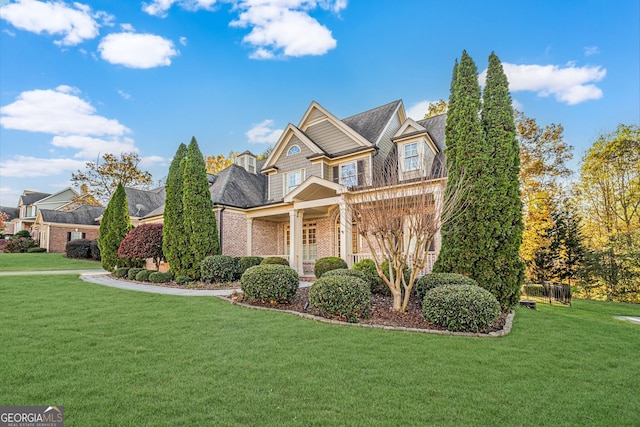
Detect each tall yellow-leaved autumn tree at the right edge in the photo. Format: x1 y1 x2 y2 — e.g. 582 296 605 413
579 124 640 302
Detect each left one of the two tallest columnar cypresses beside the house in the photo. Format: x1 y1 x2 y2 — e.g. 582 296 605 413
434 51 491 278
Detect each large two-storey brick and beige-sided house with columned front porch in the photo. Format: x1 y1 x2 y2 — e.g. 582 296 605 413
135 100 446 275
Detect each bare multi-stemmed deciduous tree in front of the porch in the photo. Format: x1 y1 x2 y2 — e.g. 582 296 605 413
345 159 465 312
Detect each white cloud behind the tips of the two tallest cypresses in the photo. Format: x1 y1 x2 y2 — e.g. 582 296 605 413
479 63 607 105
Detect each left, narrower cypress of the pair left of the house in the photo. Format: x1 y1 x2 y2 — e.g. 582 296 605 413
162 144 188 275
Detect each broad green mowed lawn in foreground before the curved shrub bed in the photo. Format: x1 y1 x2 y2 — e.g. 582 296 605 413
0 275 640 426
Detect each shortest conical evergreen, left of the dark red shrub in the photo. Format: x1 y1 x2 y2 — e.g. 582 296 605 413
98 184 131 271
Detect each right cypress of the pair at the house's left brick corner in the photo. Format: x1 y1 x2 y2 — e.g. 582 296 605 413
182 138 220 278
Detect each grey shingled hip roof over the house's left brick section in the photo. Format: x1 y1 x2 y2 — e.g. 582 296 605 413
209 164 267 208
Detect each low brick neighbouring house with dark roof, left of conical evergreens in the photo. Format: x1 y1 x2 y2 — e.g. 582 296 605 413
33 205 105 252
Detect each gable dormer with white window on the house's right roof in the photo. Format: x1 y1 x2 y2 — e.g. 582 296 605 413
392 118 440 181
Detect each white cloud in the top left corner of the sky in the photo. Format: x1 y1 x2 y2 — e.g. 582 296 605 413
0 0 113 46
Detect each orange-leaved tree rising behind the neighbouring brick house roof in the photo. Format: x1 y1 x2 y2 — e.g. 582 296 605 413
71 153 153 202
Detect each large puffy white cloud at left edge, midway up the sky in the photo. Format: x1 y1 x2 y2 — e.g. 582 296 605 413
0 85 130 136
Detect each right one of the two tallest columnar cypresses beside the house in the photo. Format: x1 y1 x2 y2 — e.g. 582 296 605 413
475 52 524 308
